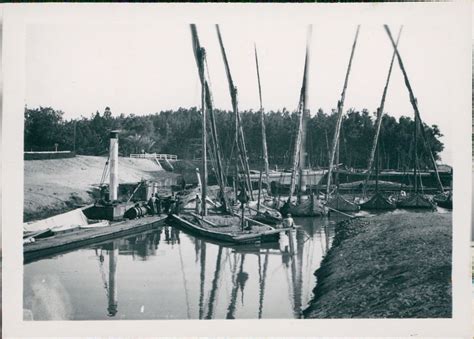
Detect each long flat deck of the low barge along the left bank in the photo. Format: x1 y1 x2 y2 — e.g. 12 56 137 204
23 215 167 263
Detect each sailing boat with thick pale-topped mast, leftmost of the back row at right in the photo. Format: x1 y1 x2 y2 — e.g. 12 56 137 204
280 26 327 217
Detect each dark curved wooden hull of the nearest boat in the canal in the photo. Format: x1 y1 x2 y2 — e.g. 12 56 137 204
168 214 286 244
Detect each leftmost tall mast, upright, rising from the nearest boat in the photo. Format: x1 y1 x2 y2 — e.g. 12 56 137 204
190 24 207 216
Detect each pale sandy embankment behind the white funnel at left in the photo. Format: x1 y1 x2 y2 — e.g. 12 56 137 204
23 155 174 221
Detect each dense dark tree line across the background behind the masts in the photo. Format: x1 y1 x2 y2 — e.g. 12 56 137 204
24 107 444 169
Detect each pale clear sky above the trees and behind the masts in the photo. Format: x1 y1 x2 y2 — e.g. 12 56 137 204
26 20 459 163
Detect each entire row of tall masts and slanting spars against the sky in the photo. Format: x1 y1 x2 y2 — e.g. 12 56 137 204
191 24 444 215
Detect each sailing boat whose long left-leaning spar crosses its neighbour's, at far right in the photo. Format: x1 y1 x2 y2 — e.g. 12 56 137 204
384 25 438 209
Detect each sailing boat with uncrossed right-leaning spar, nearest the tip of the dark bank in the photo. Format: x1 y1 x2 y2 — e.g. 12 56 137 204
326 26 360 212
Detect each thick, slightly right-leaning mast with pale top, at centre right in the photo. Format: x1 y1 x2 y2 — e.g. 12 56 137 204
288 25 312 201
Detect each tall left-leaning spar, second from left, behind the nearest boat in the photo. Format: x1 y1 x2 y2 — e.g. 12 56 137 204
216 25 253 200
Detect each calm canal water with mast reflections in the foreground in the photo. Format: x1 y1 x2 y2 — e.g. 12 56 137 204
23 217 342 320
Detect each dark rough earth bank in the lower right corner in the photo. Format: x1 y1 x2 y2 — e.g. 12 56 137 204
304 213 452 318
